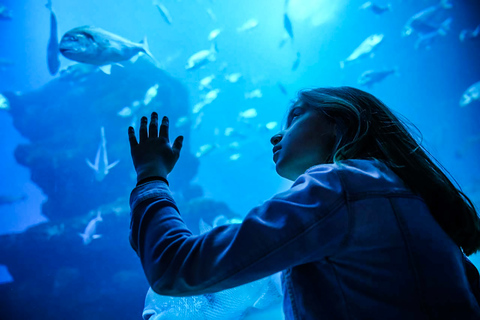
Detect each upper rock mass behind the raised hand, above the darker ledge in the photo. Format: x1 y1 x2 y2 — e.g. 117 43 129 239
2 57 198 221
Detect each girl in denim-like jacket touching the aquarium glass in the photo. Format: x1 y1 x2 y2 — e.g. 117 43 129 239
128 87 480 320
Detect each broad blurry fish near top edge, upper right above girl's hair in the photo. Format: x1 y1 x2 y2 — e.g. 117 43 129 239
402 0 452 37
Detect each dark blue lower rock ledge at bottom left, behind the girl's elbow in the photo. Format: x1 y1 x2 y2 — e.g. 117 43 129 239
0 197 238 320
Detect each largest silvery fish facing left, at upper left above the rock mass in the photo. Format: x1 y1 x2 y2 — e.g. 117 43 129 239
60 26 158 66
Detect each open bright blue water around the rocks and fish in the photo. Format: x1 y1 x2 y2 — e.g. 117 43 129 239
0 0 480 318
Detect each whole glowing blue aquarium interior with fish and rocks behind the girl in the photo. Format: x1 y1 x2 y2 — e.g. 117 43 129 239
0 0 480 320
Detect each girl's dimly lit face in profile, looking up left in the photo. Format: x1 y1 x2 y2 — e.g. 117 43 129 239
270 103 336 181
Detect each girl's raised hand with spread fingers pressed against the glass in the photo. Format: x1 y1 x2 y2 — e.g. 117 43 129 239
128 112 183 182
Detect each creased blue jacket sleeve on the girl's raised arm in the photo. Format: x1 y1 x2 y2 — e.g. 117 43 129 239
130 166 348 296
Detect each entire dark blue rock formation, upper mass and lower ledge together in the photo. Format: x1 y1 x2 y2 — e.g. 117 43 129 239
0 58 262 320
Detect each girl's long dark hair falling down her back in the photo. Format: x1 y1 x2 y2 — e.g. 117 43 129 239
295 87 480 255
